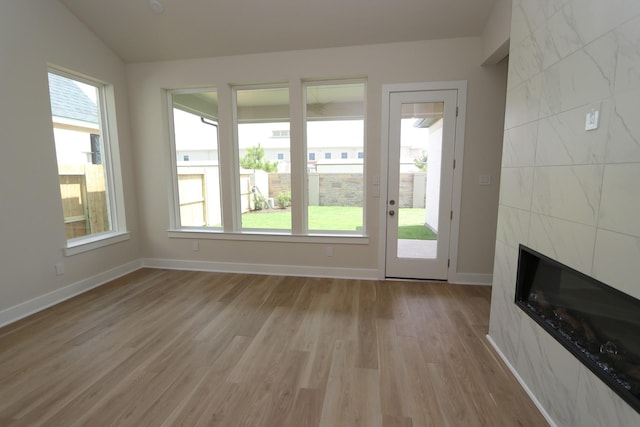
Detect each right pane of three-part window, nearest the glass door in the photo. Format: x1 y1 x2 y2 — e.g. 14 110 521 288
304 82 365 234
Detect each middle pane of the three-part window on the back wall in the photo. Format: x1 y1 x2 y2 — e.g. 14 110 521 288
233 86 291 232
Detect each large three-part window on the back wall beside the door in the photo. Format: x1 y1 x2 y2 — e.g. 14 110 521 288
169 80 365 240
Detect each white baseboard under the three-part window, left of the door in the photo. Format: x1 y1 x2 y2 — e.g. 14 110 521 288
142 258 378 280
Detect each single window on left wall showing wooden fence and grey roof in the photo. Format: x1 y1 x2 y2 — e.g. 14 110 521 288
48 69 126 251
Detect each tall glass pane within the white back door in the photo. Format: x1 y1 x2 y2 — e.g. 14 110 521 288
397 102 444 259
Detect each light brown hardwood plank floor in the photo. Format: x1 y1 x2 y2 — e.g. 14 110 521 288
0 269 546 427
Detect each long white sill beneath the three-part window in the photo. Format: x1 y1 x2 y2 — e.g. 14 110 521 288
169 229 369 245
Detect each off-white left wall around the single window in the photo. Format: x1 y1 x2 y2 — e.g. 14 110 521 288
0 0 139 324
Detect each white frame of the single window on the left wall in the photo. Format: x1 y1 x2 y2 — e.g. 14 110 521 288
47 65 131 256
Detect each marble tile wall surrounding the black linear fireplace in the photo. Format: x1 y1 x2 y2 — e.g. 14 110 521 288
489 0 640 427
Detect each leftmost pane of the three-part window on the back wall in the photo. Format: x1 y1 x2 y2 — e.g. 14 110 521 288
169 89 222 229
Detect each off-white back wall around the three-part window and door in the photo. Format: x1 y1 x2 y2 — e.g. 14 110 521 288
127 37 506 275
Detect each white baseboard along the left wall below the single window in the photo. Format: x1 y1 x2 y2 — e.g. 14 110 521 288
0 260 142 327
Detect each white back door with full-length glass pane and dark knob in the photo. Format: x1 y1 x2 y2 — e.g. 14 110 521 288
385 90 457 280
